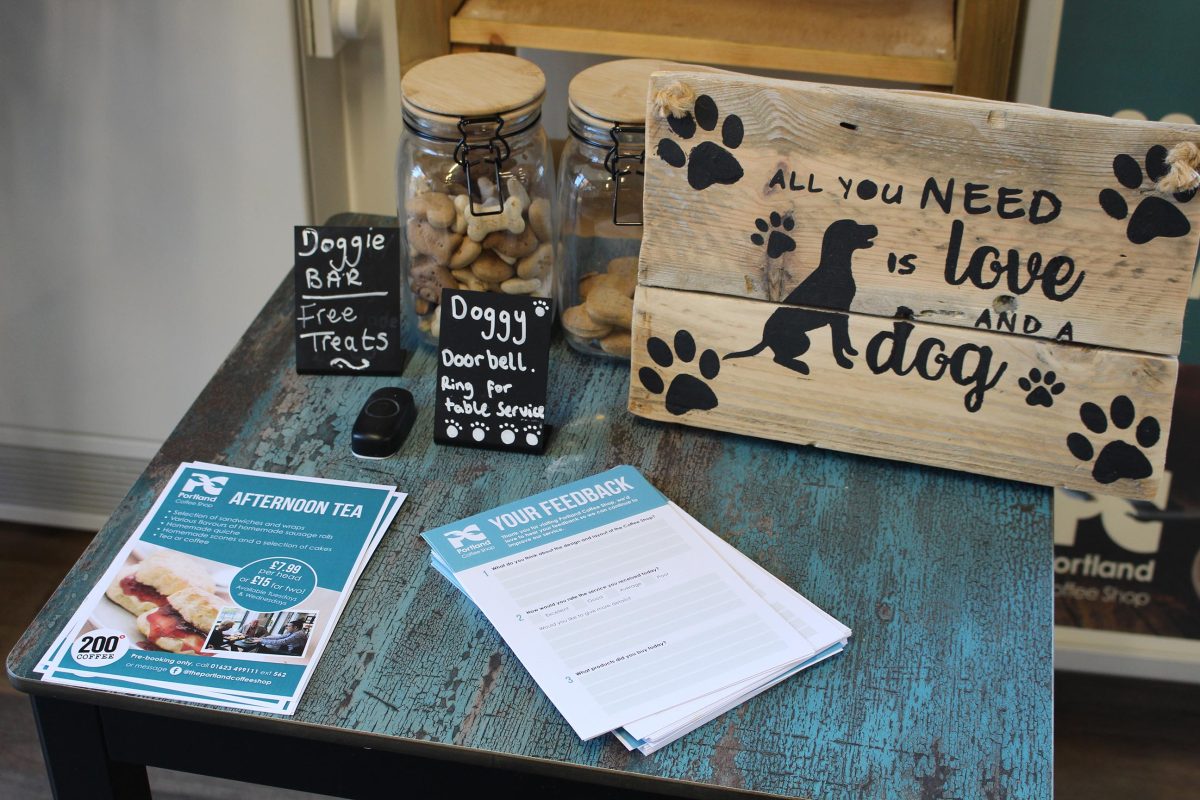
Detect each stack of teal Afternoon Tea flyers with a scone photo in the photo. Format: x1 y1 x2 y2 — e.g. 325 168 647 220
37 462 406 714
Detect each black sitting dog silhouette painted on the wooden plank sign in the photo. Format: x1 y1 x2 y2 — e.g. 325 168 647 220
725 219 878 375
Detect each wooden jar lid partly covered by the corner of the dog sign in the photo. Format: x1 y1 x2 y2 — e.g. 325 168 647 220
566 59 685 127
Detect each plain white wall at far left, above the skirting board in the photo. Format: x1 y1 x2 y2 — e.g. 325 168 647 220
0 0 308 456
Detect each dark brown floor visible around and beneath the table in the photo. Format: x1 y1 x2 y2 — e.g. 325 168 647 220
0 522 1200 800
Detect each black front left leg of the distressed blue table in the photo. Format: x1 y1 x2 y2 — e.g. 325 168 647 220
31 696 150 800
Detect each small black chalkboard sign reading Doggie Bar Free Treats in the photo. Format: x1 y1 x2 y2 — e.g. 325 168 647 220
295 225 406 375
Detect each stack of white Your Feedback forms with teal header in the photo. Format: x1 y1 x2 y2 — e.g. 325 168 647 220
424 467 850 754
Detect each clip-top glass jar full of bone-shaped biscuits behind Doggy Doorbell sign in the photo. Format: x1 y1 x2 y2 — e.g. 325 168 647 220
396 53 557 344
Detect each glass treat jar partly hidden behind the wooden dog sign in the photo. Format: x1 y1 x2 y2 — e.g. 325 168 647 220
556 59 678 359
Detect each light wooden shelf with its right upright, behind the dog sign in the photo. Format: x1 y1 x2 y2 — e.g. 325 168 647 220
449 0 1020 100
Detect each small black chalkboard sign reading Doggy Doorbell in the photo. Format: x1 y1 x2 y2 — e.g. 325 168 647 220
433 289 553 453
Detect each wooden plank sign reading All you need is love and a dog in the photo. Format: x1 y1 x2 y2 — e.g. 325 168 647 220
629 72 1200 498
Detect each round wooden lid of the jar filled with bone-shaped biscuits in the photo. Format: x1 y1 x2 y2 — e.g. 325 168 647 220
400 53 546 122
